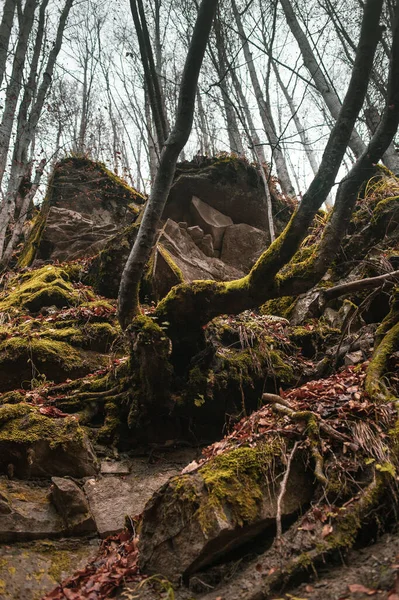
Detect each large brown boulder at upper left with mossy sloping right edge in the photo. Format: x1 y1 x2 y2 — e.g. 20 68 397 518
19 157 145 266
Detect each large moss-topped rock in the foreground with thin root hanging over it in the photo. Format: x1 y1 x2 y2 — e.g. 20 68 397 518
139 448 313 581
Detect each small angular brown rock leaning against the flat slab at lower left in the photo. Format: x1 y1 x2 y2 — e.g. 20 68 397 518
51 477 96 535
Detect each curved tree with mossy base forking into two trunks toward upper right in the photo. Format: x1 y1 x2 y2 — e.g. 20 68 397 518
151 0 399 344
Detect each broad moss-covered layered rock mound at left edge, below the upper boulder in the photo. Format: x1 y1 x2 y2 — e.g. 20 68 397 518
0 265 118 393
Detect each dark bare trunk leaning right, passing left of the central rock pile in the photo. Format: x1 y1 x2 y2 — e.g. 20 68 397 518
118 0 217 329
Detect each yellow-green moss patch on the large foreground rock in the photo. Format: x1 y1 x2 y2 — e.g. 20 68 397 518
198 439 282 532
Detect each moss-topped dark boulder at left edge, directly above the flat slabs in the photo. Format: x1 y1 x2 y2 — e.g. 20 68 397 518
0 403 97 478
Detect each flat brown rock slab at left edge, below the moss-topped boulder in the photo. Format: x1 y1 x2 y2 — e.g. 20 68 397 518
0 479 66 542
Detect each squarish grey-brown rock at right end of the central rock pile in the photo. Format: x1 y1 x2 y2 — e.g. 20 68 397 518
220 223 270 273
